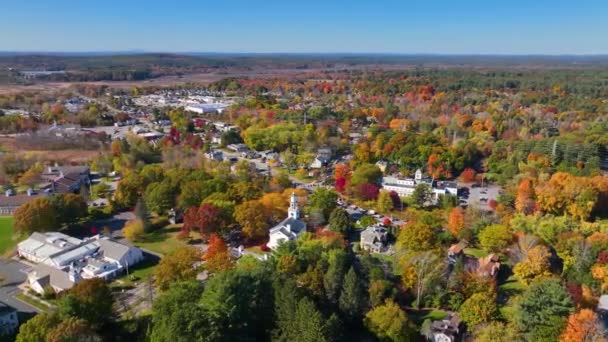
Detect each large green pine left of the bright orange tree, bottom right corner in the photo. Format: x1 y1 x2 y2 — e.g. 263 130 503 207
514 279 574 341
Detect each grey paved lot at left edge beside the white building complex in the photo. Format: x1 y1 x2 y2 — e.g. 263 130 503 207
0 259 40 314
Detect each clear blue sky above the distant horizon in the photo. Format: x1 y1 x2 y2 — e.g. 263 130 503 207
0 0 608 54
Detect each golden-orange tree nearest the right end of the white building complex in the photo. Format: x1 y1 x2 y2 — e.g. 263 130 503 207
154 247 201 290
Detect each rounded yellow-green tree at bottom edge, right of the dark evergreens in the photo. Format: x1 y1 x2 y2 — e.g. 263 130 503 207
364 300 412 342
